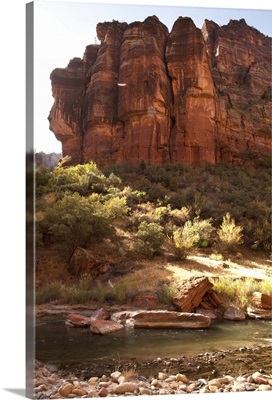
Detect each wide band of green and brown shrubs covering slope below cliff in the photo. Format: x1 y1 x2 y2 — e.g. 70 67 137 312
35 154 271 256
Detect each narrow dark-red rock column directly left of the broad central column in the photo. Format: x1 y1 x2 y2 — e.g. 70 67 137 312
82 21 127 165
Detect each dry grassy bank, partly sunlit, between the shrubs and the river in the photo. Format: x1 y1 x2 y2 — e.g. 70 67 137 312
36 244 272 304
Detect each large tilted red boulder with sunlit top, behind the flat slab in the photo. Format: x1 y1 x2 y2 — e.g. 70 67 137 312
173 276 213 312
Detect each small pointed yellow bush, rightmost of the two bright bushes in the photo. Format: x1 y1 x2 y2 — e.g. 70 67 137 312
217 213 243 250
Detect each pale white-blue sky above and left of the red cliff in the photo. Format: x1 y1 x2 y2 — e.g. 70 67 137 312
34 0 272 152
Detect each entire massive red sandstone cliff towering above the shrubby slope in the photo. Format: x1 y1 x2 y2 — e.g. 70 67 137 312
49 16 271 166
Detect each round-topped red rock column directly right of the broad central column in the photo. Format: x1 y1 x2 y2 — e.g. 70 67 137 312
166 17 217 164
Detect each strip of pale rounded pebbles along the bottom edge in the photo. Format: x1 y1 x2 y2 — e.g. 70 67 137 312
33 367 272 400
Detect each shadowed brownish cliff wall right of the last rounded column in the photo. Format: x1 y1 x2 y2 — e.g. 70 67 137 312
202 19 272 162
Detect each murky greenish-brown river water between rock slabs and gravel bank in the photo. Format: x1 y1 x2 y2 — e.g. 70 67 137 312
35 317 272 374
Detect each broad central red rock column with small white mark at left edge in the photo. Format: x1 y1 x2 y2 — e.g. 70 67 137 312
118 16 172 165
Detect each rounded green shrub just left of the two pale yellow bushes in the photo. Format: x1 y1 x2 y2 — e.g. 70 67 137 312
137 221 164 258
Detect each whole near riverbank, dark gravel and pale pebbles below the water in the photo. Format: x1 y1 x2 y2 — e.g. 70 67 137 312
34 346 272 399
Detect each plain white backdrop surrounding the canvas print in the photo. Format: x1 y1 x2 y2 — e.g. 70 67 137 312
0 0 271 400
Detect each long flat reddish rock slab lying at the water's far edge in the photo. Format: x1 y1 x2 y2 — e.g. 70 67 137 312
133 310 211 329
